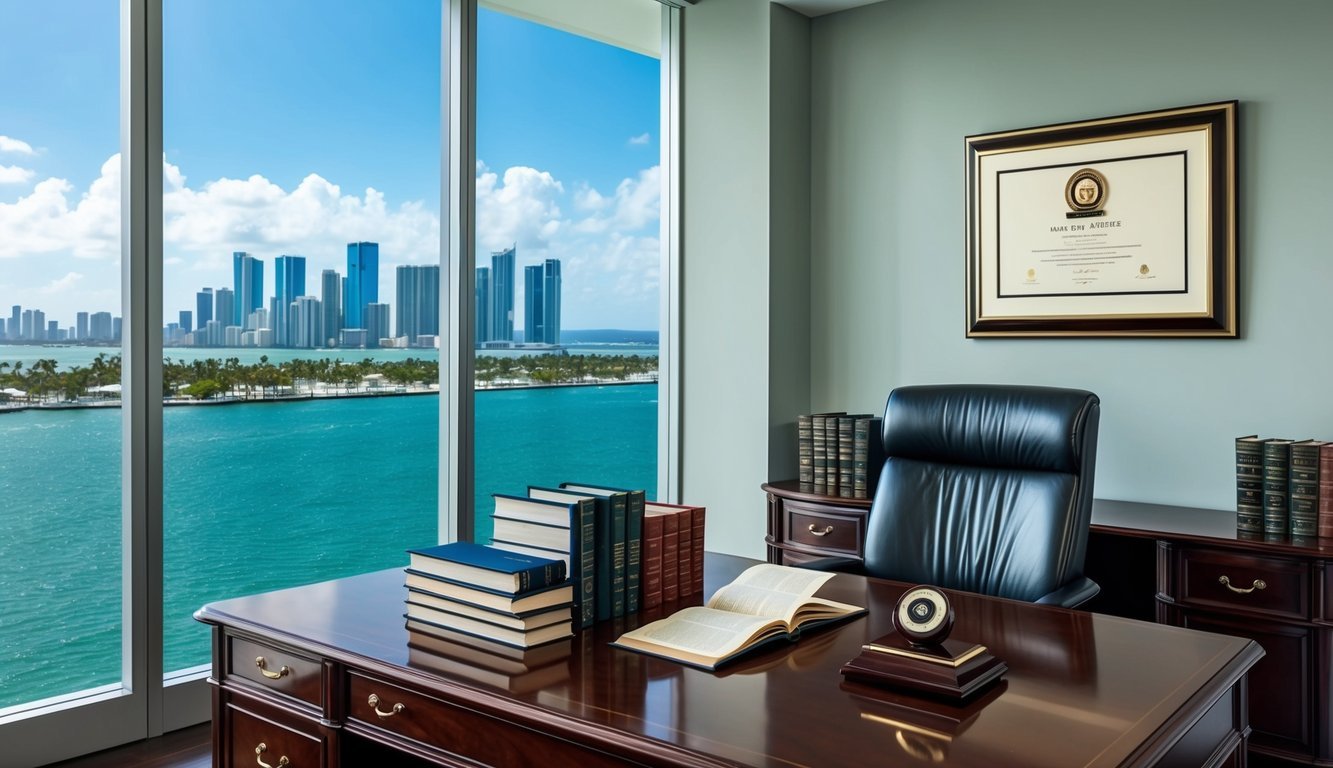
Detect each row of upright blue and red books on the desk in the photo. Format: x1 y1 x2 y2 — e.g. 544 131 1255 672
491 483 705 627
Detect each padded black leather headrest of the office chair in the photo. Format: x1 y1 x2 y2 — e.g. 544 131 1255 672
884 384 1101 473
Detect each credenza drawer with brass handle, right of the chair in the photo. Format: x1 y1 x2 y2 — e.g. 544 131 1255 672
1177 549 1310 619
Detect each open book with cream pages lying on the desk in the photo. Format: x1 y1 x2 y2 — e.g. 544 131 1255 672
613 563 865 669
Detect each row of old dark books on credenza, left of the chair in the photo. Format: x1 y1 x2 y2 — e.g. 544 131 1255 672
796 411 884 499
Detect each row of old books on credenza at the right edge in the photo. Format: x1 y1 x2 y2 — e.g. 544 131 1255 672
1236 435 1333 539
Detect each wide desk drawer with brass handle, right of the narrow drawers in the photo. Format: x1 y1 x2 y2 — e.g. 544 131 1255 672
347 672 627 768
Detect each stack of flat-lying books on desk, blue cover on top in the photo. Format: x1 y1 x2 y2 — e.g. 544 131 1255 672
404 541 573 648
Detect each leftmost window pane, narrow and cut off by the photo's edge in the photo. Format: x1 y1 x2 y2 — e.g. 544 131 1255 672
0 0 123 719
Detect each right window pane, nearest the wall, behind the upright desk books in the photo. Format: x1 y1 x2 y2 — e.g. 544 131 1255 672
472 0 661 541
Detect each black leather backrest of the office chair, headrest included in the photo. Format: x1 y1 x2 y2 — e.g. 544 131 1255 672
865 384 1101 600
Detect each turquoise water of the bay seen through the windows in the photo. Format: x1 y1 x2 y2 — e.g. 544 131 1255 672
0 384 657 708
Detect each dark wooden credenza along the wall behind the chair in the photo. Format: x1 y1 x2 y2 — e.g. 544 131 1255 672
762 481 1333 767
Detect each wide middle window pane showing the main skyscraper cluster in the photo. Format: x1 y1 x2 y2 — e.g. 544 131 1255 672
163 0 441 673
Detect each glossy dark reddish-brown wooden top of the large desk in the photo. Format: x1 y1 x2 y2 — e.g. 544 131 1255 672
197 553 1262 768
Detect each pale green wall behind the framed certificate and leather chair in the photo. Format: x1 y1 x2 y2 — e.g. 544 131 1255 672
805 0 1333 509
